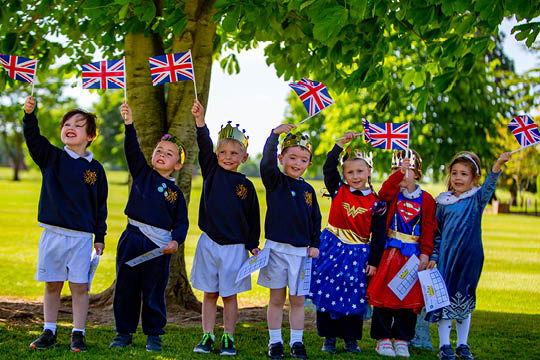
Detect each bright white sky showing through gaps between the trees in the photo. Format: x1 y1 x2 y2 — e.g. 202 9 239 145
70 16 540 155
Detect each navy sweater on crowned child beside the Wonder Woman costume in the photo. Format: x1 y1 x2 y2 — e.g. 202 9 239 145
261 131 321 248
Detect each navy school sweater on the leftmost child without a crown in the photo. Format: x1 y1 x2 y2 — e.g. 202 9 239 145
23 112 108 243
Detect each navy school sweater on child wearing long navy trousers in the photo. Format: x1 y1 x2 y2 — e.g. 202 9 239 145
124 124 189 245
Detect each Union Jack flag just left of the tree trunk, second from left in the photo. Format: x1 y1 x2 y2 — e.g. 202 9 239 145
82 59 126 89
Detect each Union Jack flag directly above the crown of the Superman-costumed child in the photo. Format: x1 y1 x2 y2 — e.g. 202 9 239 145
362 120 409 150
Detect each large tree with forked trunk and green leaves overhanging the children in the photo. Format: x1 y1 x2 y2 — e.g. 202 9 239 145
0 0 540 307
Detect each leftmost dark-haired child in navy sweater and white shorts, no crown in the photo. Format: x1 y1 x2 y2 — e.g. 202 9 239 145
23 96 108 352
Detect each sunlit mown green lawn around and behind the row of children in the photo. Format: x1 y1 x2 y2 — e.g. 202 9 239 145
0 168 540 359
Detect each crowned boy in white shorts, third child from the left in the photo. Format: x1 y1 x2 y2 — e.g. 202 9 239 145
190 100 261 355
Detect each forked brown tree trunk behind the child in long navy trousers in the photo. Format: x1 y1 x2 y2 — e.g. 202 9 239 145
90 0 216 311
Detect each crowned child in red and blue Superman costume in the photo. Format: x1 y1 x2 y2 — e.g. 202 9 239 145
367 150 437 357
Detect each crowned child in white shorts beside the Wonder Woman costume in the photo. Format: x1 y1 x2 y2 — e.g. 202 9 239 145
257 124 321 359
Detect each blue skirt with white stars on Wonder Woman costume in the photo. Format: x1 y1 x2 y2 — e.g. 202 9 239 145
308 229 369 319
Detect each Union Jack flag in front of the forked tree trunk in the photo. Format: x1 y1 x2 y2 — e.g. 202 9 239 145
148 51 194 86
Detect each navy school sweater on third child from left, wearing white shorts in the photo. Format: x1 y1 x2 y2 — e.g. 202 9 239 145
197 126 261 250
